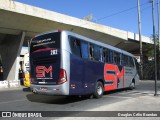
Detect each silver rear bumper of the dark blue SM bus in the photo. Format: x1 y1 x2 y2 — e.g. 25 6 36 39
30 84 69 95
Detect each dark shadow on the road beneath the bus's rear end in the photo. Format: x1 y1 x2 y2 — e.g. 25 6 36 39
26 94 88 105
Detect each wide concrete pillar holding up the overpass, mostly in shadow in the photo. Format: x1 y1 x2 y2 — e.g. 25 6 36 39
0 32 25 81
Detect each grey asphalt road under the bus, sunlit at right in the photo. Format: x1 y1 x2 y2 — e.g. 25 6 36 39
0 81 160 119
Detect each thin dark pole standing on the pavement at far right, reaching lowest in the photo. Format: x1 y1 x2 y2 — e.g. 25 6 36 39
152 0 157 96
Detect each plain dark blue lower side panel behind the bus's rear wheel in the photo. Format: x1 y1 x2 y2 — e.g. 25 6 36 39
69 55 104 95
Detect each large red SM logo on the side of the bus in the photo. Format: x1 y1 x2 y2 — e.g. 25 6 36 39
104 64 125 91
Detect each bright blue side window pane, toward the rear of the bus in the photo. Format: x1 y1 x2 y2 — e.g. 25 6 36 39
81 41 89 59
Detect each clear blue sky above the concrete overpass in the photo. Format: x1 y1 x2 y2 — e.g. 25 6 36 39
16 0 158 37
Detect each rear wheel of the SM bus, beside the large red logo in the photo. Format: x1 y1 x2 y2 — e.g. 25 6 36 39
93 81 104 99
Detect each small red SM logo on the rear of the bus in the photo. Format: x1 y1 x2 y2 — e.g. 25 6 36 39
36 66 52 78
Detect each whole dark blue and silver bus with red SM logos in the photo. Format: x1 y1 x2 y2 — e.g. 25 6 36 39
30 30 139 98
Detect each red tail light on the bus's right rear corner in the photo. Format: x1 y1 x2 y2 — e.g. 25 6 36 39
58 69 67 85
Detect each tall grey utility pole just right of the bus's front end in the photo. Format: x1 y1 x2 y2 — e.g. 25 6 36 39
137 0 143 79
